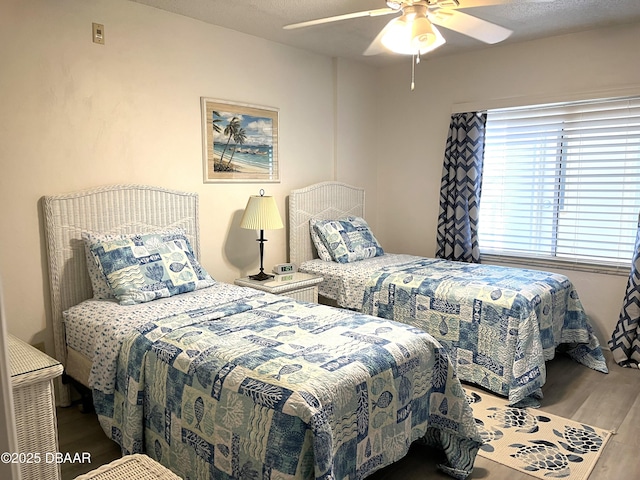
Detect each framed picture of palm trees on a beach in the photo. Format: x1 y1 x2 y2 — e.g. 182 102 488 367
201 97 280 183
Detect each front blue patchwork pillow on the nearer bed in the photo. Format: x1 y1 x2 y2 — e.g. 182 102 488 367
89 231 215 305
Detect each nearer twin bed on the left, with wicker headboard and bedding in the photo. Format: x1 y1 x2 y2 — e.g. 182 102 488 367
43 185 482 479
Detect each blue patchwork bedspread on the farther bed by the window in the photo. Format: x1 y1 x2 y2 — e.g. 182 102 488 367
362 258 607 404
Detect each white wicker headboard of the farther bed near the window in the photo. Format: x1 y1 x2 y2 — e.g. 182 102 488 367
289 182 364 265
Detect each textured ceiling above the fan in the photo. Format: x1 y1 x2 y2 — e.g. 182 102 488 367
127 0 640 65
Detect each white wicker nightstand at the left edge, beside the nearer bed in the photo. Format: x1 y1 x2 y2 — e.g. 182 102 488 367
7 335 63 480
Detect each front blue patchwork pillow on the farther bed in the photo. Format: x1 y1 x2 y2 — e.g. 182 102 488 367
313 217 384 263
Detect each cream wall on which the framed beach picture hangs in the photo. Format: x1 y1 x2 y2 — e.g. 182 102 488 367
0 0 375 353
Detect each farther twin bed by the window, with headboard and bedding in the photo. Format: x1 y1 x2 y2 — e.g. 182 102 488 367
289 182 607 404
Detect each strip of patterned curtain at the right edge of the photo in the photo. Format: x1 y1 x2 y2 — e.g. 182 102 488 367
609 217 640 368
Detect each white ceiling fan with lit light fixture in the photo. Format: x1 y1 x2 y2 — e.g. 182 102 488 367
283 0 553 56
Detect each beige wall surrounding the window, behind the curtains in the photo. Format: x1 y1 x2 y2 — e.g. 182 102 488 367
377 24 640 343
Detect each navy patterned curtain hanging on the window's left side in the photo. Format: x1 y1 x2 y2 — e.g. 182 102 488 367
436 112 487 263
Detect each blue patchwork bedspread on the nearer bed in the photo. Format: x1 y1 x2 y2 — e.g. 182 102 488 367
94 288 481 479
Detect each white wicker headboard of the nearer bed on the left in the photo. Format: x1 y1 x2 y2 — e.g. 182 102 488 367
43 185 200 398
